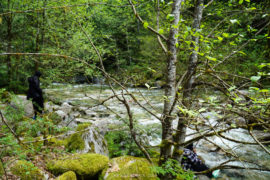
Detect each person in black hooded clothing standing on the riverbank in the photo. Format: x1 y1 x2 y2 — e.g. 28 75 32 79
27 71 44 119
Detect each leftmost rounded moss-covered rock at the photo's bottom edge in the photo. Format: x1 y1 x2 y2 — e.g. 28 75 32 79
10 160 44 180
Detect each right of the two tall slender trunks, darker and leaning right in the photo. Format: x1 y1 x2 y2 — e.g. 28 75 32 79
173 0 204 161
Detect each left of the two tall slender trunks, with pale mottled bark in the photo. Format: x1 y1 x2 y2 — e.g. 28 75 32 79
160 0 183 164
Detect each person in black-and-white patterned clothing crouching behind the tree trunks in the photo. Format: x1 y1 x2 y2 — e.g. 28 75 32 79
181 144 212 178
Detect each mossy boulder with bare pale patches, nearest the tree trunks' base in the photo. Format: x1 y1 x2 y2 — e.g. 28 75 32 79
100 156 157 180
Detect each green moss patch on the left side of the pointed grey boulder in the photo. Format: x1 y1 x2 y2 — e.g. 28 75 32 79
65 123 91 152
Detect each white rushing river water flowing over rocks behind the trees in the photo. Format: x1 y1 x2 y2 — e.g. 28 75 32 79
45 84 270 179
